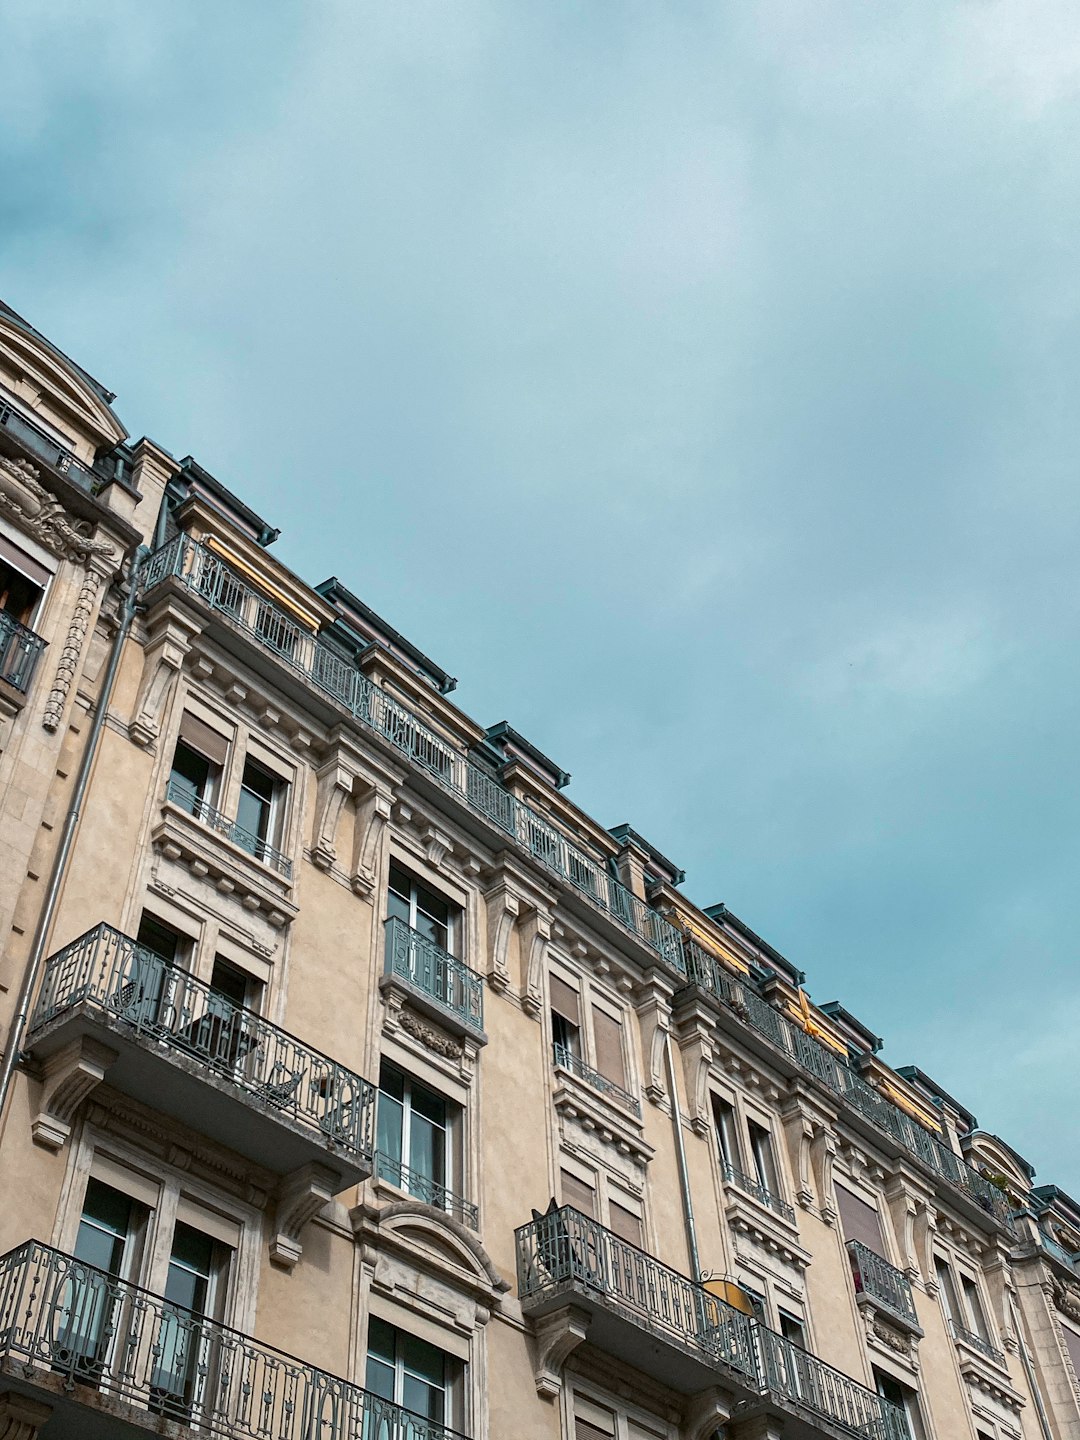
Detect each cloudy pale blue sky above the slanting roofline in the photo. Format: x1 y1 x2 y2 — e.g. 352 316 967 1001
0 0 1080 1195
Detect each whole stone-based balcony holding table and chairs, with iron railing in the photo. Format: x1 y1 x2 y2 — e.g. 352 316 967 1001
27 924 374 1189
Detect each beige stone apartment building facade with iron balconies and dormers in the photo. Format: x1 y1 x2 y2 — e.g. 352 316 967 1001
0 292 1080 1440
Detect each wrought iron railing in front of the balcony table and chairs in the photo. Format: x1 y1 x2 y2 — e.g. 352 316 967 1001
29 924 376 1161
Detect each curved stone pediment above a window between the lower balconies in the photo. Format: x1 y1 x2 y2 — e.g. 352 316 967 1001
351 1201 510 1308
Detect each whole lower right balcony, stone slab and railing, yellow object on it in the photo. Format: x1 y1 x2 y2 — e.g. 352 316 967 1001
517 1205 907 1440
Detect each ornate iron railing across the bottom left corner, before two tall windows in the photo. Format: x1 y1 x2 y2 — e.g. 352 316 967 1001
0 1240 465 1440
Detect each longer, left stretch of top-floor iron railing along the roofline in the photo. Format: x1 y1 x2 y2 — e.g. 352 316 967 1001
141 534 683 973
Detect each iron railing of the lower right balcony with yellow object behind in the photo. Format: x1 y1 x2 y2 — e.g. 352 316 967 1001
516 1205 909 1440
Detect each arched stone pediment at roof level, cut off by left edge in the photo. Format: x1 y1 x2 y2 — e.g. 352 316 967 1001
0 314 128 449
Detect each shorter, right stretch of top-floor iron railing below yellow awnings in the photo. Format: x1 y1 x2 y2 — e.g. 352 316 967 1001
684 937 1012 1230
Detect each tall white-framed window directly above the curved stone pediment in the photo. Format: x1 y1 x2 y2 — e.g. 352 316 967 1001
377 1063 461 1210
